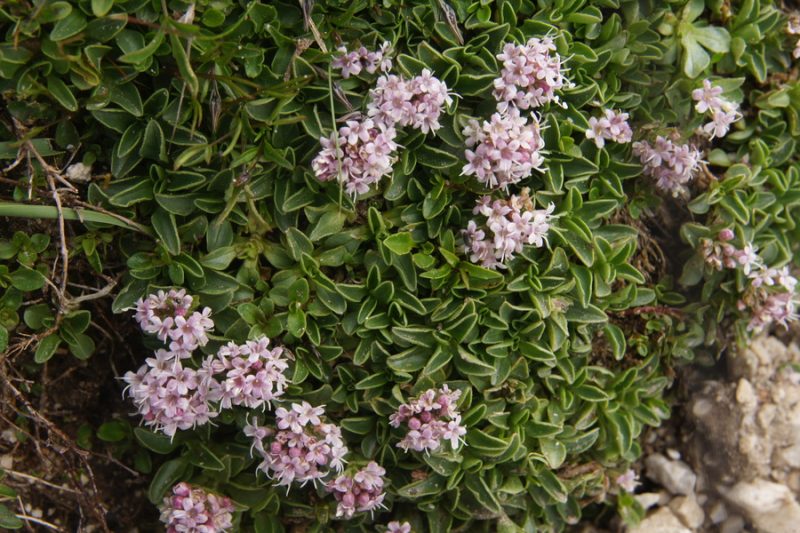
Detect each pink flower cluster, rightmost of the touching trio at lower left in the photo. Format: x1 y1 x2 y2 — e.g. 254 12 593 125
210 337 289 409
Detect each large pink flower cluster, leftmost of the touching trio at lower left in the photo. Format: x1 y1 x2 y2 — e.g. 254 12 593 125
123 350 219 437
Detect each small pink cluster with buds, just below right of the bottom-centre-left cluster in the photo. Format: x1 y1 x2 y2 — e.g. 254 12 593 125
325 461 386 518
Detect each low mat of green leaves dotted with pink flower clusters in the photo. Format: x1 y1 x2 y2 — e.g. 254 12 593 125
0 0 800 533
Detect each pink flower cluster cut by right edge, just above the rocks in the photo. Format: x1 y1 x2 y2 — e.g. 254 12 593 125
738 266 798 331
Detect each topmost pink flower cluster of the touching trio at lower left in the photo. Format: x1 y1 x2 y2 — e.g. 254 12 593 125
136 289 214 358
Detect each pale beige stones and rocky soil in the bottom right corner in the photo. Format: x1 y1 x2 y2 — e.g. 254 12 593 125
620 336 800 533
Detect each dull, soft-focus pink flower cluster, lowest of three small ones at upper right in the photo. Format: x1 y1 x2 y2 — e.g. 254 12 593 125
633 135 702 197
